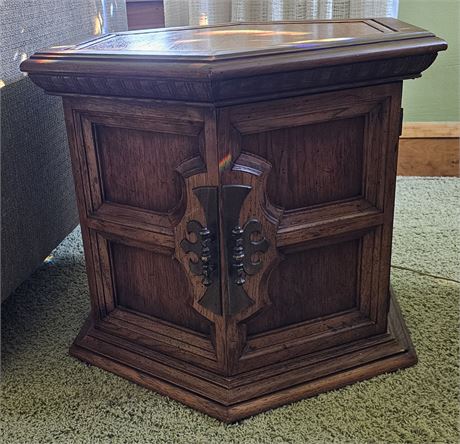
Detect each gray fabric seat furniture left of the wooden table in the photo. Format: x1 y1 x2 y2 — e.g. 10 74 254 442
0 0 127 301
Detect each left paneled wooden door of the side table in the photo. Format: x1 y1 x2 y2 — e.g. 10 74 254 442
65 99 223 371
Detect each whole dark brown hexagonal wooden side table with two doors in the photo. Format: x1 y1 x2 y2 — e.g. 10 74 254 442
22 19 447 421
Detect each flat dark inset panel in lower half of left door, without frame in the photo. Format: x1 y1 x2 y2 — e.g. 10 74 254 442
110 242 211 334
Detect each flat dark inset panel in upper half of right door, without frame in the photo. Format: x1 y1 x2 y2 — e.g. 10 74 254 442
241 116 365 210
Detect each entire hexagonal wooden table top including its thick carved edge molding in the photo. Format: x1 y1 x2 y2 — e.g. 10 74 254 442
21 18 447 101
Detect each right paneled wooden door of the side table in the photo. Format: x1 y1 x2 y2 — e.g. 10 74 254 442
218 84 401 374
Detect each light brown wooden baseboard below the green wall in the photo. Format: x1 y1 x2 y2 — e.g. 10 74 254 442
398 122 460 177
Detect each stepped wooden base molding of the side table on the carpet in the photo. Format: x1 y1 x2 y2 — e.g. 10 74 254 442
70 291 417 422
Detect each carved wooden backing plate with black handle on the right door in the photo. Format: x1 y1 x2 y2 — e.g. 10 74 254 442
221 152 283 324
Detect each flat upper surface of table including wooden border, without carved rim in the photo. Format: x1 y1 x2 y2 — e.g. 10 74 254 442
24 18 433 62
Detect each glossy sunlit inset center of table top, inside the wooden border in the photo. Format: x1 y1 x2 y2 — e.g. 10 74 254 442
82 21 382 56
